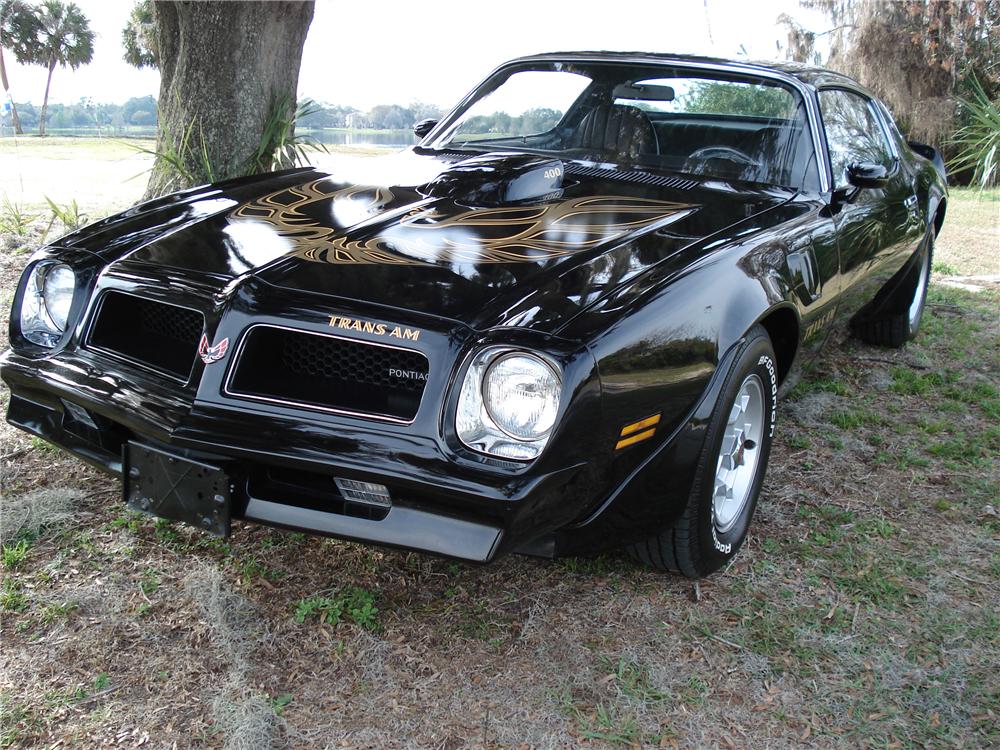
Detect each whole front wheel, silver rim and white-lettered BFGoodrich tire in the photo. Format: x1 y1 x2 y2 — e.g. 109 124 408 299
629 326 778 578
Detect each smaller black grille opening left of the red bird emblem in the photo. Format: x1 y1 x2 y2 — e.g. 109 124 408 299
87 292 205 380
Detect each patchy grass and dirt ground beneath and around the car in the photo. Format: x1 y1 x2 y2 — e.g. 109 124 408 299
0 142 1000 750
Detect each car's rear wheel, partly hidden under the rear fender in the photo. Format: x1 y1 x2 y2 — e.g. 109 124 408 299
852 232 934 349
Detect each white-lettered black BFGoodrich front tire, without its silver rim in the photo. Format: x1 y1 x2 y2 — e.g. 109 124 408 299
628 325 778 578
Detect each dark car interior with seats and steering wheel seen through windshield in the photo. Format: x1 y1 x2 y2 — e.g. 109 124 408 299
442 66 818 188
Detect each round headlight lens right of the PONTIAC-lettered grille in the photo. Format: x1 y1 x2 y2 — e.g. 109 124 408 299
483 353 562 440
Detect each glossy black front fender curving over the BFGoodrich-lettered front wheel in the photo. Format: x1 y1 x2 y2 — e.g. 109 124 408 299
557 220 830 549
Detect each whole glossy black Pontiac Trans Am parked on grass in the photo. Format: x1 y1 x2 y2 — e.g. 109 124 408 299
0 52 947 576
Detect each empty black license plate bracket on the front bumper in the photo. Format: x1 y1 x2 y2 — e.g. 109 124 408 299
122 441 232 537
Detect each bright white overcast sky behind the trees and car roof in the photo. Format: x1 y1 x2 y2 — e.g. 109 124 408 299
0 0 822 109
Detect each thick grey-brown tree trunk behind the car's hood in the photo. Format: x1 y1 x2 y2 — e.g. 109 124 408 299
146 0 313 197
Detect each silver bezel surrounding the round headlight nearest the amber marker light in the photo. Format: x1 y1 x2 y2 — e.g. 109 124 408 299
452 345 565 464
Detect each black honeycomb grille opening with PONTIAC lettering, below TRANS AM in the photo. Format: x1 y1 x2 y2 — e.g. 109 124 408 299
227 325 428 422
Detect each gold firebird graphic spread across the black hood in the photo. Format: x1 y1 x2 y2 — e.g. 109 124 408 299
231 178 697 265
